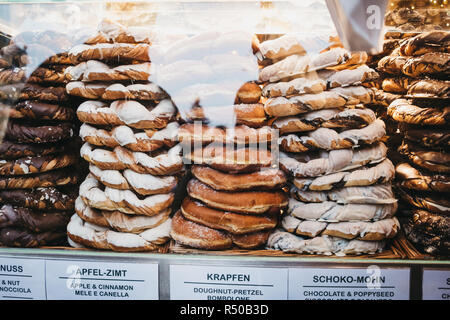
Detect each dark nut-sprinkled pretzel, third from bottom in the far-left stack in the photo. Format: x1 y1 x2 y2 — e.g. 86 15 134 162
0 187 77 210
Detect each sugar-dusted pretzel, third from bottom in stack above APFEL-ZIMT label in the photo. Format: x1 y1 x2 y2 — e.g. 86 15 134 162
79 174 174 216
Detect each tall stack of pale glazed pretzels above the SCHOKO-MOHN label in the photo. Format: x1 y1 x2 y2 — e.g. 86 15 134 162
259 34 399 255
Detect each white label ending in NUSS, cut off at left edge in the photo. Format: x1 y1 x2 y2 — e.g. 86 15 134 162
0 258 46 300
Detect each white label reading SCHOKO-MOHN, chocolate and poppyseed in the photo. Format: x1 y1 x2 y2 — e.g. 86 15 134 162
289 265 409 300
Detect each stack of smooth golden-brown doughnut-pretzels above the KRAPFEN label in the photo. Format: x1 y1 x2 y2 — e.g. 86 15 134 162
166 32 287 250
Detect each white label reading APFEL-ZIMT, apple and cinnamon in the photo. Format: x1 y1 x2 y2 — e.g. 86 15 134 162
47 260 159 300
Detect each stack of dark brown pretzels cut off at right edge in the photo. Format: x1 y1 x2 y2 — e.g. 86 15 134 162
379 31 450 255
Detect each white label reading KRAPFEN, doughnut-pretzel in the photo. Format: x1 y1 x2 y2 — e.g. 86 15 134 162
170 265 287 300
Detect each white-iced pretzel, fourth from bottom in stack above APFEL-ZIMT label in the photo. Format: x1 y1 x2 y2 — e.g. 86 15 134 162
89 164 178 196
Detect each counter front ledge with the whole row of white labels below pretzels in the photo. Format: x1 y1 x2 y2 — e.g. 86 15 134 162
0 248 450 300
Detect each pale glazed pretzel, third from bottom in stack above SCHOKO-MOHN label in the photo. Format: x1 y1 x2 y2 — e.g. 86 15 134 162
287 198 398 222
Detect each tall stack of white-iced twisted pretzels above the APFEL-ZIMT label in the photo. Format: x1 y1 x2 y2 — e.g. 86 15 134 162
65 21 183 252
